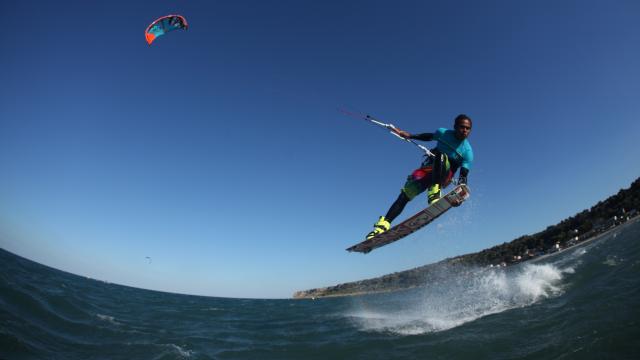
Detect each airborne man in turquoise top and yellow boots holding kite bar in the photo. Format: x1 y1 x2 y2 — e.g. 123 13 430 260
367 114 473 239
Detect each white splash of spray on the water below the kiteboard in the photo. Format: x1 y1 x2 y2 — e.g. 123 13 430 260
347 264 574 335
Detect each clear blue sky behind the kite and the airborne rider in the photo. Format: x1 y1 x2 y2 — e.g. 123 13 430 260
0 0 640 297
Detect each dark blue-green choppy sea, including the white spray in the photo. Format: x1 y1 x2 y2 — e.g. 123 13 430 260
0 222 640 360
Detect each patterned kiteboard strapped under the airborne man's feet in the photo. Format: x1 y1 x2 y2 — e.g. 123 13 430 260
347 184 470 254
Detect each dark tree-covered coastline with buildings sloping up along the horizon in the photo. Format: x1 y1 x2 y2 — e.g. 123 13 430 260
293 178 640 299
